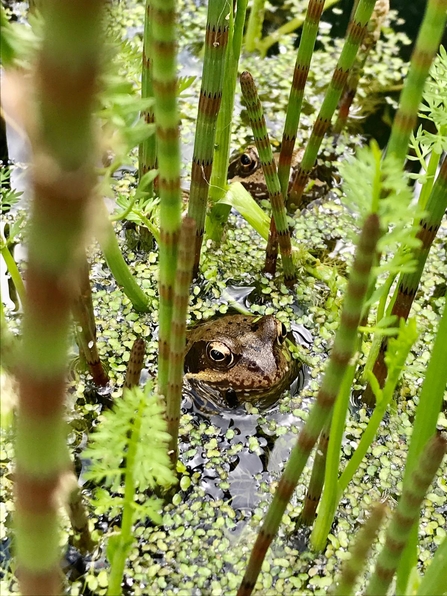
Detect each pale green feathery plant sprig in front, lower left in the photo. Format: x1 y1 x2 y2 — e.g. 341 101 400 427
83 382 176 595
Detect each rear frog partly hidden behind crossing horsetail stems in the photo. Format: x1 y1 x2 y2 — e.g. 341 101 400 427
228 145 332 207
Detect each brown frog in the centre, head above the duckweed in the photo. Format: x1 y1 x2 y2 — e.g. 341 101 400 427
185 315 302 410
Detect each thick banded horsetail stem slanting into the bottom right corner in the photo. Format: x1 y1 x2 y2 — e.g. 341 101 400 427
365 435 447 596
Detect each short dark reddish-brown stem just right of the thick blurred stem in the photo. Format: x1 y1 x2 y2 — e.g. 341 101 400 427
72 254 109 387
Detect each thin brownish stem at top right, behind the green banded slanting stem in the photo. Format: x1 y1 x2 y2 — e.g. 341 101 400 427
334 0 390 134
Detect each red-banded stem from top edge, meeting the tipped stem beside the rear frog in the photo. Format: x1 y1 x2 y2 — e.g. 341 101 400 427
278 0 324 200
